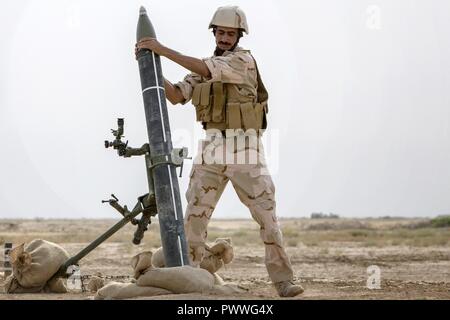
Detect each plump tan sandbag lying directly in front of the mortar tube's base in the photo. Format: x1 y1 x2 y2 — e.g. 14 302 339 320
136 266 214 293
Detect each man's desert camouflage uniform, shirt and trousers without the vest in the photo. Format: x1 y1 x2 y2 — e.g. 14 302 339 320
176 47 293 282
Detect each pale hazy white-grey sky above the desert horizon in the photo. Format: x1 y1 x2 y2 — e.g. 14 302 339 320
0 0 450 218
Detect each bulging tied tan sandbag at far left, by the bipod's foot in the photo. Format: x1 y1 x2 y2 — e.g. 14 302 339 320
7 239 69 293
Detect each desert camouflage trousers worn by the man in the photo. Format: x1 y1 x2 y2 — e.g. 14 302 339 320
185 133 293 282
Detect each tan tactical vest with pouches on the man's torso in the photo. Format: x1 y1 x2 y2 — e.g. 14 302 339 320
192 56 269 132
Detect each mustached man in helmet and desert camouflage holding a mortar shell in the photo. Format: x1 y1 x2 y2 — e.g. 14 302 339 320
136 6 303 297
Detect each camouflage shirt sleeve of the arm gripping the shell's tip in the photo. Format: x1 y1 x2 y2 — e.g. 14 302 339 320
203 51 255 84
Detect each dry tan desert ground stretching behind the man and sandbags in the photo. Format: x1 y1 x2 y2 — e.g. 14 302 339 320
0 218 450 300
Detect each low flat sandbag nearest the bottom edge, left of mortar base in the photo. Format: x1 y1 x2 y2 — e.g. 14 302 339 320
94 282 172 300
